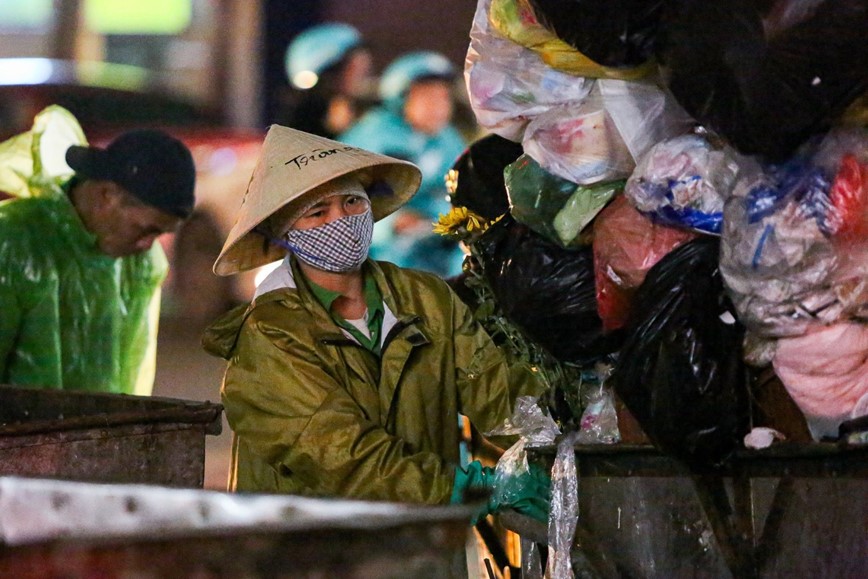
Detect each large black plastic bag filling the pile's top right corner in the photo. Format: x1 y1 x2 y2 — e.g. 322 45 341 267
657 0 868 162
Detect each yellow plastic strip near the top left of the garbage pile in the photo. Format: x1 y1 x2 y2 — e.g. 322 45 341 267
489 0 656 80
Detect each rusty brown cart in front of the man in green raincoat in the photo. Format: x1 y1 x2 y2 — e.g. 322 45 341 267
0 386 223 487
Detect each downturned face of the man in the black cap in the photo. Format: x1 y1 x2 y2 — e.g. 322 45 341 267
93 187 183 257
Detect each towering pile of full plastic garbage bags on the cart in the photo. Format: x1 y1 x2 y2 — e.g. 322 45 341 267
453 0 868 466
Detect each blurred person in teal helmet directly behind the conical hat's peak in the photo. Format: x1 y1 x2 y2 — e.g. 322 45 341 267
278 22 374 138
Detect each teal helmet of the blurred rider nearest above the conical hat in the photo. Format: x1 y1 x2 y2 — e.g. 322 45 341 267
286 22 362 89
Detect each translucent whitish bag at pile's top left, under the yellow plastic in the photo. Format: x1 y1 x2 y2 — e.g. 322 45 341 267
464 0 593 142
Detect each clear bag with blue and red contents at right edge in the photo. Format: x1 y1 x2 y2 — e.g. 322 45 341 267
720 132 868 338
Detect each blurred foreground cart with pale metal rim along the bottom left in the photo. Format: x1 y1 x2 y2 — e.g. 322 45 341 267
0 477 478 579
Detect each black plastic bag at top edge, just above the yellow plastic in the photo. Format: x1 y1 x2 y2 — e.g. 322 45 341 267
530 0 663 67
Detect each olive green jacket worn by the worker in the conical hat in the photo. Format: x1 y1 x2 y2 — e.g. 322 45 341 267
203 260 542 504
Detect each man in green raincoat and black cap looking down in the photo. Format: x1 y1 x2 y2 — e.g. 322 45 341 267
0 107 195 395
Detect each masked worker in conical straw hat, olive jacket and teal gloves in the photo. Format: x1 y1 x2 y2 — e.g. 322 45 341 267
203 125 549 520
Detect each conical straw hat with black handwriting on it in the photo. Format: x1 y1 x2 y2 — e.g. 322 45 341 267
214 125 422 275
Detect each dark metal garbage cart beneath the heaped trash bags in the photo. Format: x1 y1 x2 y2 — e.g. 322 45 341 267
516 442 868 579
